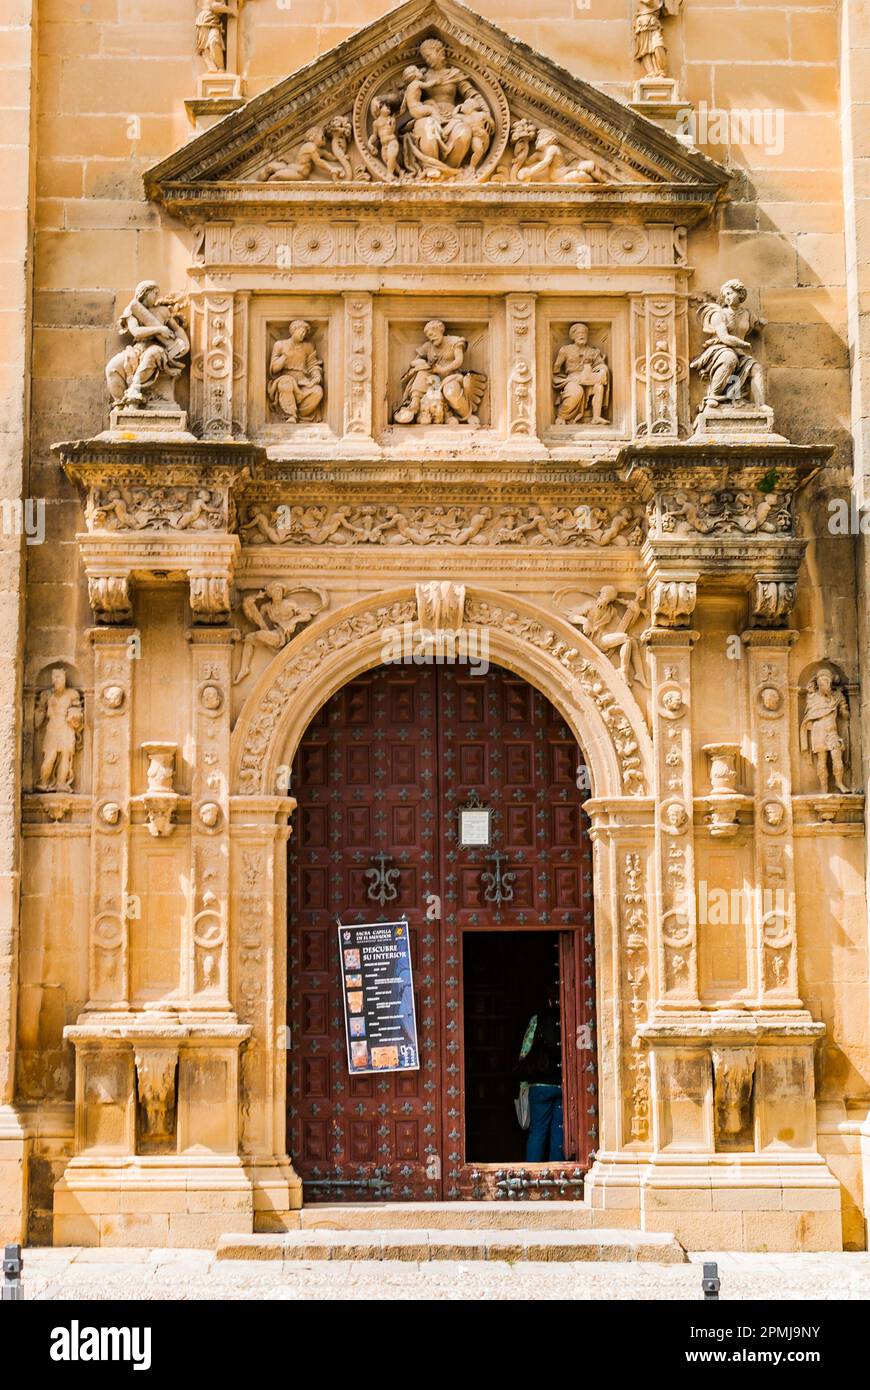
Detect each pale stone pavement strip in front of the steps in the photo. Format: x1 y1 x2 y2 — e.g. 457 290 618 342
15 1250 870 1300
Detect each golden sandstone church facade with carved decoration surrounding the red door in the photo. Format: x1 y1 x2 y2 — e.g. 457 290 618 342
0 0 870 1250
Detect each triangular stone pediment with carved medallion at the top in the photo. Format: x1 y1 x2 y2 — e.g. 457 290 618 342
146 0 728 210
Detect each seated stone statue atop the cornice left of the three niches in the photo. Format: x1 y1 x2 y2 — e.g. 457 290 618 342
106 279 190 410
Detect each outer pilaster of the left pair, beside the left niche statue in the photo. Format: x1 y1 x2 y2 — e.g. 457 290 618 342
88 627 139 1012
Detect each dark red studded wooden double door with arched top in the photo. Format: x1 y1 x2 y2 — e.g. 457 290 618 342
288 664 598 1202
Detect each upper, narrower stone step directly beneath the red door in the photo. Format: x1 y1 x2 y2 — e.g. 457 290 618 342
296 1201 589 1230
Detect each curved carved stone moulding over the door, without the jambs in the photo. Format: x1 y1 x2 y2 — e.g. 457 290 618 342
231 588 653 798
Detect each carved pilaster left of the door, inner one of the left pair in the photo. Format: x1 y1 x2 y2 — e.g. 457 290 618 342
182 628 233 1012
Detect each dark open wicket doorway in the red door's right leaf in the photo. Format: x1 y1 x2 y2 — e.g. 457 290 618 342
463 931 559 1163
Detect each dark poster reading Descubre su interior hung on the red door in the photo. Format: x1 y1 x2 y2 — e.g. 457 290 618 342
338 922 420 1076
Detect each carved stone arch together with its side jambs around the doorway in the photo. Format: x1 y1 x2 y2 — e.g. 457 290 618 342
231 587 653 1227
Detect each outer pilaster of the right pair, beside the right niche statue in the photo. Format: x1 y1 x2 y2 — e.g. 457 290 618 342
742 628 802 1009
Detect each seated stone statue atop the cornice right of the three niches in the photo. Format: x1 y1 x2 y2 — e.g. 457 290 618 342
691 279 766 410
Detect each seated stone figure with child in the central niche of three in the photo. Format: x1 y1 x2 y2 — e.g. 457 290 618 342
393 318 486 427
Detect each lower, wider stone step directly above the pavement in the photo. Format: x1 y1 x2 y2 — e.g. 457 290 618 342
217 1227 687 1265
